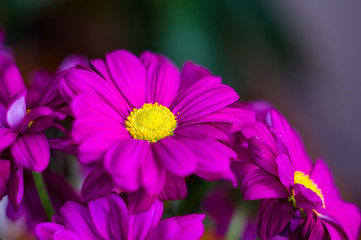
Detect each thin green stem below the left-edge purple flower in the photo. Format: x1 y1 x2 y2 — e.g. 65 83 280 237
33 172 55 222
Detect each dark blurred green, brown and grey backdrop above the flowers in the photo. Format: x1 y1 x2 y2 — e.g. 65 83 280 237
0 0 361 206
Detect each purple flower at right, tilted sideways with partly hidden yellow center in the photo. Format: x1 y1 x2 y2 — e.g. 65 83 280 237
233 103 360 239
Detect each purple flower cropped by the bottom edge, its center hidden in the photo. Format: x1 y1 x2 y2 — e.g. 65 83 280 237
35 194 204 240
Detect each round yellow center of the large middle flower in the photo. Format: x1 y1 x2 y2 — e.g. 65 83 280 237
125 103 177 143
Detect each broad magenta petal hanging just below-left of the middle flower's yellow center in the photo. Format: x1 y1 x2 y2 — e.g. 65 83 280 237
104 138 150 191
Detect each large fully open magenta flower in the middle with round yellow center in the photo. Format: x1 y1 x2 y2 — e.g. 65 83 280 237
60 50 253 208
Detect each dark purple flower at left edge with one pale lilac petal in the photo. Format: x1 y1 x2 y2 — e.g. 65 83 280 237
0 37 87 210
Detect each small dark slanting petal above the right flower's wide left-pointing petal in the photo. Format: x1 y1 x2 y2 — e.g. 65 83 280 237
248 137 278 176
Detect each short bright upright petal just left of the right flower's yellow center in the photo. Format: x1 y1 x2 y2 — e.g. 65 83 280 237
276 154 294 190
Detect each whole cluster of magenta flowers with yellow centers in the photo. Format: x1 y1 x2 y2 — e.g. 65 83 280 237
0 30 360 240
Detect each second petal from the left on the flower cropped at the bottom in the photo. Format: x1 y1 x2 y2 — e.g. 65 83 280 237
60 202 100 240
